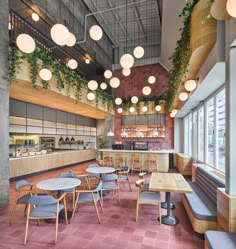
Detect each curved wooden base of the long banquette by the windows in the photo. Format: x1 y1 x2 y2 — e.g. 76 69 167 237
180 194 217 234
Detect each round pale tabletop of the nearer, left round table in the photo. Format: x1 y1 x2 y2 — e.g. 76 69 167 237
36 178 81 190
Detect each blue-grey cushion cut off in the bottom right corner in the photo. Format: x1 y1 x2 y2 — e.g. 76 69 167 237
205 231 236 249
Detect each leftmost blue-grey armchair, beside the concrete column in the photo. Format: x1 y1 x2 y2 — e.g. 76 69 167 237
10 180 33 224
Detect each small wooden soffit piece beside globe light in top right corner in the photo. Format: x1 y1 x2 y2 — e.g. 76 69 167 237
211 0 231 20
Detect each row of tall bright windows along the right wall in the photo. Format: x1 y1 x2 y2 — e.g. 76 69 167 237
184 89 225 172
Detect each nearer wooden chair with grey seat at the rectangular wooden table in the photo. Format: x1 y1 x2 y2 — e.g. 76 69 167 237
136 180 161 224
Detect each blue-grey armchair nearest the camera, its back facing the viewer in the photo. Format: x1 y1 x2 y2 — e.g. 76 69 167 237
24 193 68 244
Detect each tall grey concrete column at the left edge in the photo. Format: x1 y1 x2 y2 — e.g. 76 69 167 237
0 0 9 205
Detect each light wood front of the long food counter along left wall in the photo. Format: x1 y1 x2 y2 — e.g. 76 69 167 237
10 149 96 178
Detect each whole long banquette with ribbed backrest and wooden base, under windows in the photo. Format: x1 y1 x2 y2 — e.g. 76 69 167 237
181 167 225 234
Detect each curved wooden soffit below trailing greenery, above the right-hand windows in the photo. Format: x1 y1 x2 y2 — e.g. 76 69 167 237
173 0 217 109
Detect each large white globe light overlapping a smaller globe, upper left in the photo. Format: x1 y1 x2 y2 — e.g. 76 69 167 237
50 23 69 46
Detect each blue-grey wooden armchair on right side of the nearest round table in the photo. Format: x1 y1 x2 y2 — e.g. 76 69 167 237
71 181 102 223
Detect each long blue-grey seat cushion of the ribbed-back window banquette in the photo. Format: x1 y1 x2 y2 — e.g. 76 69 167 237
184 182 217 221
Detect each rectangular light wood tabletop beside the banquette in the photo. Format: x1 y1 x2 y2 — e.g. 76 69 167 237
149 173 192 193
